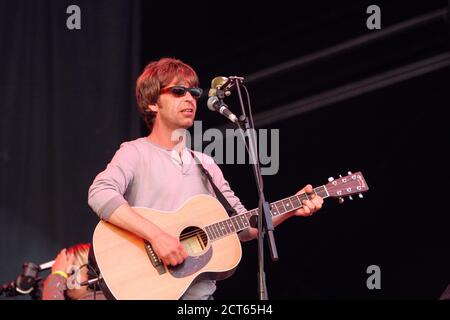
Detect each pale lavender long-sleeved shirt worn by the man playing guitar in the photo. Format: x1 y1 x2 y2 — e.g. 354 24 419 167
88 137 246 299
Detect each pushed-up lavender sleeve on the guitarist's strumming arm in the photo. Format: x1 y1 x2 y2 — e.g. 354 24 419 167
88 142 139 220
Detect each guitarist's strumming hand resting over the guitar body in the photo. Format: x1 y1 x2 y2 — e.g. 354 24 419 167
151 231 188 266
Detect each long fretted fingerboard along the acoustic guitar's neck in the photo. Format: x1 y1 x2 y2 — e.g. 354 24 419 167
205 186 329 241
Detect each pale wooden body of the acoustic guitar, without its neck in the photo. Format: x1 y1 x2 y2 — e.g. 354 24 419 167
92 195 242 300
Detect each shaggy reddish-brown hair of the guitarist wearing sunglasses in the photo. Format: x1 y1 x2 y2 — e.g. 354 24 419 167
136 58 198 132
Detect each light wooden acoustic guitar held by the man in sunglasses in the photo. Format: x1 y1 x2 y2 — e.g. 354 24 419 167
92 172 369 300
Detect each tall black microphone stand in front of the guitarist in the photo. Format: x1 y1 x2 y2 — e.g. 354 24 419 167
217 77 278 300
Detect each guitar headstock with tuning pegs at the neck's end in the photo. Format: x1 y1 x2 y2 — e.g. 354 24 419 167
325 172 369 203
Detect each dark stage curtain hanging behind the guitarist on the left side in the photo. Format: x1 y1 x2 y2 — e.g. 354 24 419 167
0 0 141 298
